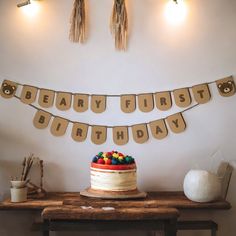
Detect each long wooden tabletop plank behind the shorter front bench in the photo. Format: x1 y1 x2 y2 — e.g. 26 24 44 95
0 192 231 210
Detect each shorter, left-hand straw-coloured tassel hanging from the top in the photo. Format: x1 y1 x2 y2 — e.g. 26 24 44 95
69 0 86 43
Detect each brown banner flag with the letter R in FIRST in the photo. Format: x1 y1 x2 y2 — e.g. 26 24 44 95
155 91 172 111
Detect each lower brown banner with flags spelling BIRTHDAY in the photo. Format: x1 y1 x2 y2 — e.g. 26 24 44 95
10 93 199 145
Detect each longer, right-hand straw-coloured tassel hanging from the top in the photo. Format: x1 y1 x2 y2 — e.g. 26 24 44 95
110 0 128 51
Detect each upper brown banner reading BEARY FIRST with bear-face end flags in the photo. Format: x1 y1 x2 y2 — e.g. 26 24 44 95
0 76 236 113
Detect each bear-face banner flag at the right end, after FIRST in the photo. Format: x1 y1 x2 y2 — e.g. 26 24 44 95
216 76 236 97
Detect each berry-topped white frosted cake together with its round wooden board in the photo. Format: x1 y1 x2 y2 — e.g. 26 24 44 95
80 151 147 199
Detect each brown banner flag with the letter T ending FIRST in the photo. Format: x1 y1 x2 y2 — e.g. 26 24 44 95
192 84 211 104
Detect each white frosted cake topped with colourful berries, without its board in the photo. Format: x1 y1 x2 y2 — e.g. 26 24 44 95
90 151 137 192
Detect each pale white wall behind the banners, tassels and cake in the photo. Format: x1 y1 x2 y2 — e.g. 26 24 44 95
0 0 236 236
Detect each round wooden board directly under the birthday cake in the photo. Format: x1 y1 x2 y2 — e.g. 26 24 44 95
80 188 147 199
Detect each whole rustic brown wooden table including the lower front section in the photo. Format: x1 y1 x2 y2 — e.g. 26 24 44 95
0 192 231 236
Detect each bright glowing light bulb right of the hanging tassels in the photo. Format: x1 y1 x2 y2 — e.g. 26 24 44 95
165 0 188 25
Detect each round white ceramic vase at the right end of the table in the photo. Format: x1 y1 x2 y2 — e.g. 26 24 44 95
183 170 222 202
